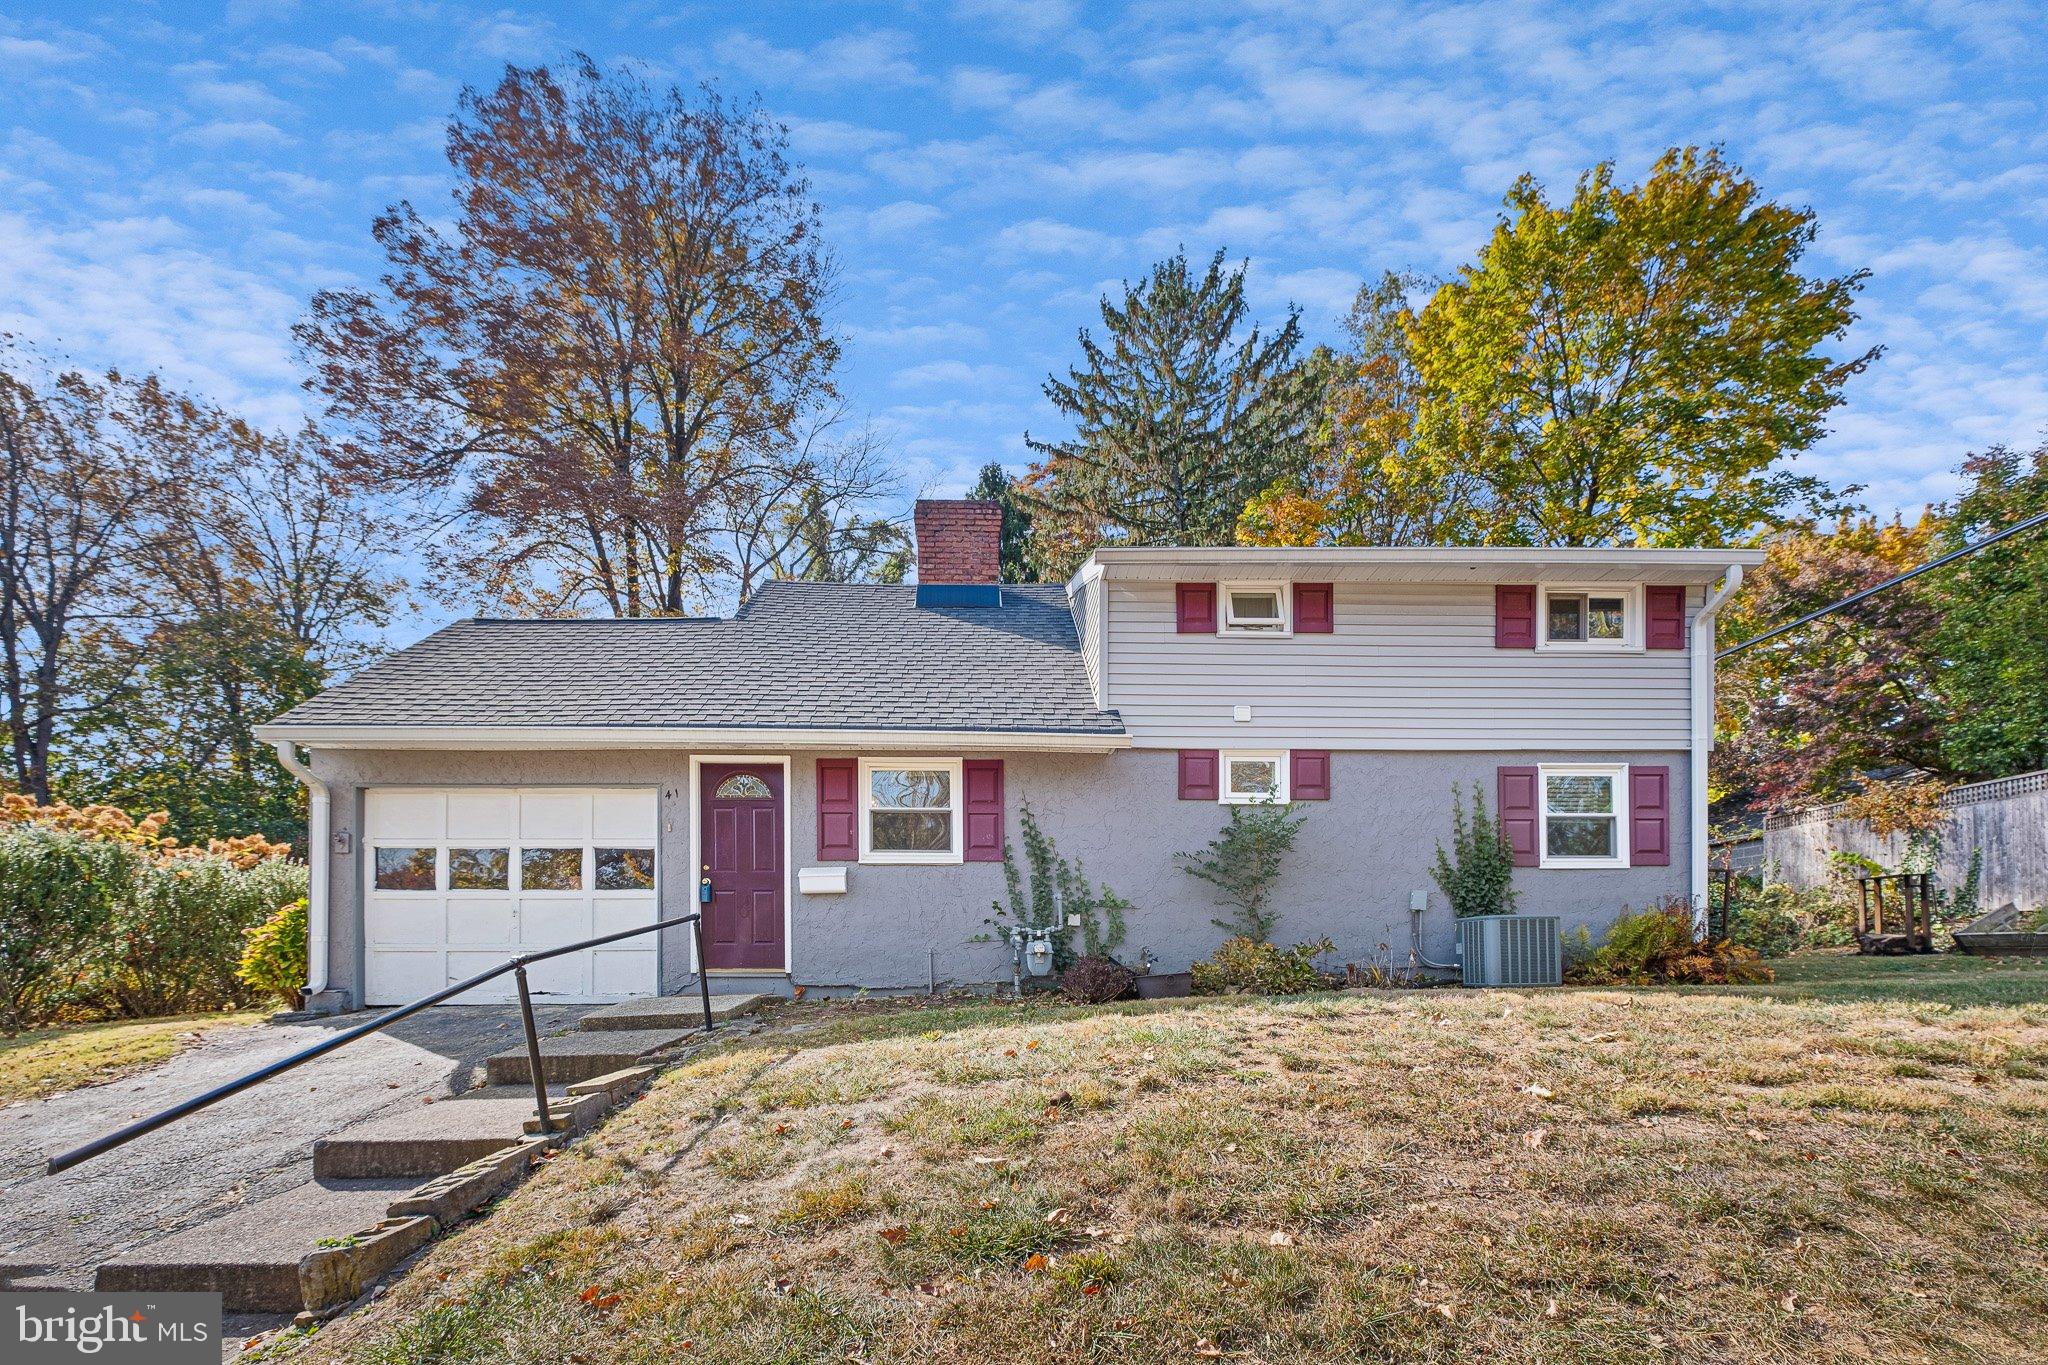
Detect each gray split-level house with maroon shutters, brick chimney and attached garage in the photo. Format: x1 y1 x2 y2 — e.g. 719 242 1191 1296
260 501 1759 1007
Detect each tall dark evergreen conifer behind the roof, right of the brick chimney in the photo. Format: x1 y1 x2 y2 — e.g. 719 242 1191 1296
1024 252 1323 579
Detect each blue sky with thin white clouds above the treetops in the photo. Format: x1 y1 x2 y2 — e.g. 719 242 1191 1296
0 0 2048 544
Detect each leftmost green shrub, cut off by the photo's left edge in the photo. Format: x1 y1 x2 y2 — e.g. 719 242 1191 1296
0 825 141 1033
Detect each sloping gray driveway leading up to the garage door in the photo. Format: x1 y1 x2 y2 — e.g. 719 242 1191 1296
0 1005 586 1289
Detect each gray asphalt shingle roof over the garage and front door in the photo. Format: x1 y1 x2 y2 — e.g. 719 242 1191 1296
276 581 1122 735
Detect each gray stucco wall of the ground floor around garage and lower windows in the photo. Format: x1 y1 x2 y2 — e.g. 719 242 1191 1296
313 749 1688 999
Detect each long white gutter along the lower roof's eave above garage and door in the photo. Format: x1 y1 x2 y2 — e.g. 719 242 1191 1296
256 724 1130 757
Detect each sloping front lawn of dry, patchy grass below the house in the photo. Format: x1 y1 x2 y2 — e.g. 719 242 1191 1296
287 968 2048 1365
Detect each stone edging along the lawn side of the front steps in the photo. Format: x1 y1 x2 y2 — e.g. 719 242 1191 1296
299 1066 659 1326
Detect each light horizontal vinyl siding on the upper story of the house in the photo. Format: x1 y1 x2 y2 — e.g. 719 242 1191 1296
1106 581 1700 753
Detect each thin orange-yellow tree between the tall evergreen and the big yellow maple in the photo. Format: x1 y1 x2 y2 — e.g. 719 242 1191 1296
1237 272 1483 544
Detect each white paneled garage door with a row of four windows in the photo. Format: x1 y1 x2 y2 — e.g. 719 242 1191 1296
362 788 657 1005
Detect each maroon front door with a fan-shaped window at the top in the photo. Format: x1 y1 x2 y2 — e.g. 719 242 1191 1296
698 763 784 972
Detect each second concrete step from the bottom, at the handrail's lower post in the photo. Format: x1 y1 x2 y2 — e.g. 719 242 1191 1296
313 1087 606 1181
